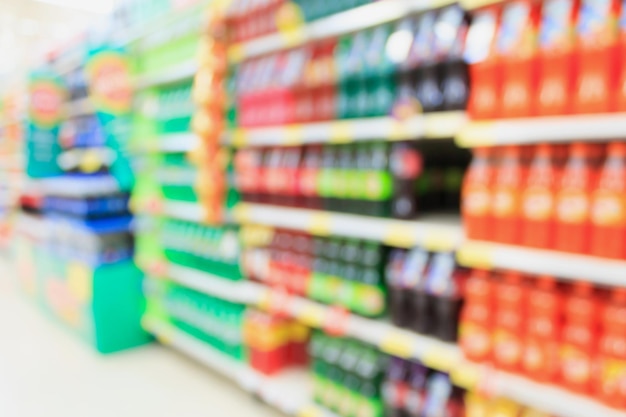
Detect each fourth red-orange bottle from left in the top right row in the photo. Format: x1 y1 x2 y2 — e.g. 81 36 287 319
573 0 621 113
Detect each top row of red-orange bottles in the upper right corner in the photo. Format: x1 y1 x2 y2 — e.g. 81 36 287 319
467 0 626 119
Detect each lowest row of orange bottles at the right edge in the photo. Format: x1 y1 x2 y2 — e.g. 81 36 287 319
460 270 626 409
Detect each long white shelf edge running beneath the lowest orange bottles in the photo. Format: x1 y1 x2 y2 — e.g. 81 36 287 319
162 265 626 417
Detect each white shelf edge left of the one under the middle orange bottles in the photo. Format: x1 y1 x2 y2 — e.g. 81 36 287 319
233 203 463 251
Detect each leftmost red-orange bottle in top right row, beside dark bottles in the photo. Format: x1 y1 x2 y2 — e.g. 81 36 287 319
464 6 501 119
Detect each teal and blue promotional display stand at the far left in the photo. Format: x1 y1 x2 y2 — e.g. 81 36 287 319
16 33 150 353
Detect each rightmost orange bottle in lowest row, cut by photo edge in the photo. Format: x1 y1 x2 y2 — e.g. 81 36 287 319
598 288 626 410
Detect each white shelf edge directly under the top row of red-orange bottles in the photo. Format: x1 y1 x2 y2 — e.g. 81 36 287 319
457 113 626 148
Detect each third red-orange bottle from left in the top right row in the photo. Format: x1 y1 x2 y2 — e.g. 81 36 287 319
535 0 578 116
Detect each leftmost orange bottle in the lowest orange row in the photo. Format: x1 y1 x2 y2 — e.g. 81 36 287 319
459 269 494 362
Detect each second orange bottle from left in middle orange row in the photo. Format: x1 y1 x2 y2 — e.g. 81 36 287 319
491 146 533 244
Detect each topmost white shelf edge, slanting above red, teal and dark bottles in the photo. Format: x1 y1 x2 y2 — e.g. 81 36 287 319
228 0 453 62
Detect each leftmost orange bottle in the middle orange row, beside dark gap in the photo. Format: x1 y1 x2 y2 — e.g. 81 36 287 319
461 148 496 240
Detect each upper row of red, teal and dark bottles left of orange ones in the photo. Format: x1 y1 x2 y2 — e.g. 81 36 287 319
231 6 469 127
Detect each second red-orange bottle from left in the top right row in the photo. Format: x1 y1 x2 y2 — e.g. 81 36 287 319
496 0 541 117
